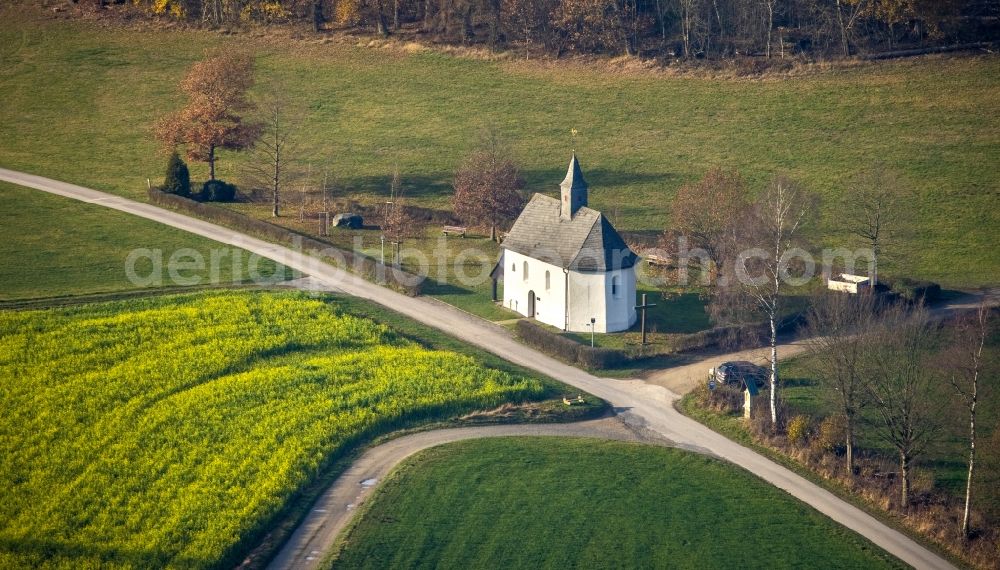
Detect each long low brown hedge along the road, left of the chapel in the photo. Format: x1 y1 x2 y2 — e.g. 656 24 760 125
149 188 424 297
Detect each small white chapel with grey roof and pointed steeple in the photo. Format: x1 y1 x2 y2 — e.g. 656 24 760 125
493 153 639 332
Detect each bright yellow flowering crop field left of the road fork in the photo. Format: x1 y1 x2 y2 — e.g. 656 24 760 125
0 292 580 568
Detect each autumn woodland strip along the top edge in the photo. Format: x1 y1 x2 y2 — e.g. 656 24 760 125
95 0 1000 59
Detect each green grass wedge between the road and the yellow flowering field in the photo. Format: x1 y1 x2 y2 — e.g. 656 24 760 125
0 183 293 301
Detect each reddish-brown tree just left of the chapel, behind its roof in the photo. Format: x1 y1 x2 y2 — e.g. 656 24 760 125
452 128 524 241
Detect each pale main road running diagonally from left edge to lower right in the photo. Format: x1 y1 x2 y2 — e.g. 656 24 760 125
0 169 953 568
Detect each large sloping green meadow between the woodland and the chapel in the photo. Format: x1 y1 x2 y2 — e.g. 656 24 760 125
0 3 1000 286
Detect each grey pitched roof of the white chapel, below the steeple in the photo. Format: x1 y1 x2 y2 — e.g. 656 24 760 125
501 194 639 272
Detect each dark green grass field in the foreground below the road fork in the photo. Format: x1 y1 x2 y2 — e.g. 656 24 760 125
332 438 902 569
